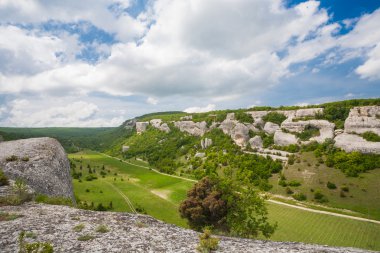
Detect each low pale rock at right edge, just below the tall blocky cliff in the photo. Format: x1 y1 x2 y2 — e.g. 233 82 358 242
334 133 380 154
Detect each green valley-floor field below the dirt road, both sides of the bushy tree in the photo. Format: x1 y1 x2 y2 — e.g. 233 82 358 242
69 152 380 250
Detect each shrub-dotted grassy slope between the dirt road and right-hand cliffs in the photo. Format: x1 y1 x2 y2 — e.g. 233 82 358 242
270 152 380 220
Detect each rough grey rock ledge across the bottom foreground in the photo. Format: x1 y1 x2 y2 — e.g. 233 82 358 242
0 203 368 253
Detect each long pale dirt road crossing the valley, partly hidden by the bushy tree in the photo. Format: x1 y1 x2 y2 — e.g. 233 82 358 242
101 153 380 224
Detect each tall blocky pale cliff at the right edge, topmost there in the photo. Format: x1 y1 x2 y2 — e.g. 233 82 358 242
344 106 380 135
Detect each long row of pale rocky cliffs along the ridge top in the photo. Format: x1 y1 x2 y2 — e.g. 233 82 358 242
136 106 380 154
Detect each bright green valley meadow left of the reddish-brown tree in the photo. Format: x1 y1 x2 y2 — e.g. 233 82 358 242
69 152 194 226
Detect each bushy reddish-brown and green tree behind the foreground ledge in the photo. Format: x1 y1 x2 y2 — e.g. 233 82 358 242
180 177 277 238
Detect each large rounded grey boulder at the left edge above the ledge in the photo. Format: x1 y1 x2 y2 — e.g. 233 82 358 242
0 138 74 200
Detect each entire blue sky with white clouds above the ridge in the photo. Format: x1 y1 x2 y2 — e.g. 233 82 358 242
0 0 380 127
